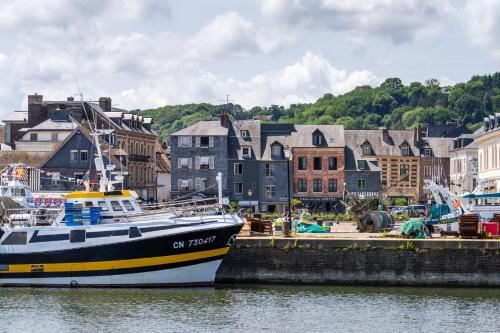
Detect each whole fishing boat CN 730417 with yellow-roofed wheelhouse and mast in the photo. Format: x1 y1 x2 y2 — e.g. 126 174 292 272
0 128 243 287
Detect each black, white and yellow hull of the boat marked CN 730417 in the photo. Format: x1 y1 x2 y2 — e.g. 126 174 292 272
0 215 242 287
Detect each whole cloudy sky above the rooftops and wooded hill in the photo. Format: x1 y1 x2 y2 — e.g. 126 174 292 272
0 0 500 119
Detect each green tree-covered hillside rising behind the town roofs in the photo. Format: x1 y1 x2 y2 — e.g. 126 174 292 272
137 72 500 139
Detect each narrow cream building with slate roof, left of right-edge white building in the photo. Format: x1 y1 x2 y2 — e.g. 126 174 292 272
450 134 477 195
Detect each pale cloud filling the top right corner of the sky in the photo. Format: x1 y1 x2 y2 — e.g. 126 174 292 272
462 0 500 61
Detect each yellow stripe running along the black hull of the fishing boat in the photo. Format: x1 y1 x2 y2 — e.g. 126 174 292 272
2 247 229 273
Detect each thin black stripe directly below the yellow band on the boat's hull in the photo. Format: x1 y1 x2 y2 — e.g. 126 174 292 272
0 255 224 278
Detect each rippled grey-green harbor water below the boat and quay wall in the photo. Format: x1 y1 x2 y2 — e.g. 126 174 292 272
0 286 500 333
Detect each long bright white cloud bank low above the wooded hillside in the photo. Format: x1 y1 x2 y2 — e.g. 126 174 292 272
102 52 381 108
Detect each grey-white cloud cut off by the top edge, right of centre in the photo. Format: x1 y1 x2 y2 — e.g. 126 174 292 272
261 0 449 43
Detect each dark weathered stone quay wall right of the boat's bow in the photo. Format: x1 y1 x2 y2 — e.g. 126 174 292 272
215 237 500 287
